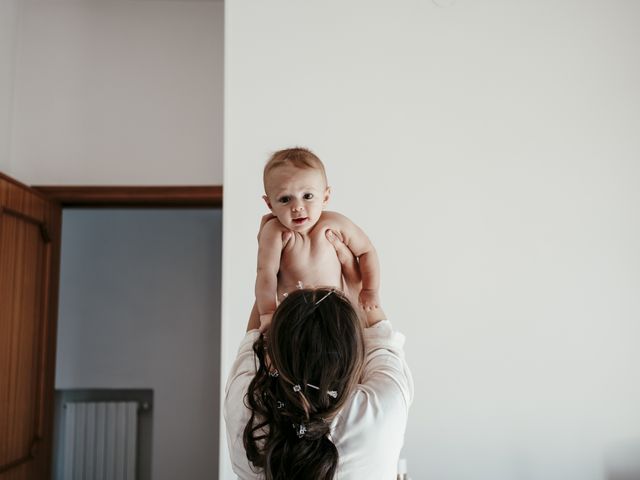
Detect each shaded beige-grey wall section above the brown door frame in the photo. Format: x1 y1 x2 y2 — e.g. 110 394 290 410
6 0 224 185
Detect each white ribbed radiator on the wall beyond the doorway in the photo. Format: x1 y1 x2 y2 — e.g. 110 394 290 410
62 402 138 480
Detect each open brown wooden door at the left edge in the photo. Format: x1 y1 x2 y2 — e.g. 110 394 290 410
0 173 61 480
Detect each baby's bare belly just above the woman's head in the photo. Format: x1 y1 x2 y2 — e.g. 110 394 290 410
278 247 342 296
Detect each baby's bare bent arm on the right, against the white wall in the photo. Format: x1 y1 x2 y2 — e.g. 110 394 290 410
327 212 380 310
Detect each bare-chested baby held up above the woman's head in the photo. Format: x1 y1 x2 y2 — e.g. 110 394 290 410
255 148 380 330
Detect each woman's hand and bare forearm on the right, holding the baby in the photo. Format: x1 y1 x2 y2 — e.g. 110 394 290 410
326 230 387 327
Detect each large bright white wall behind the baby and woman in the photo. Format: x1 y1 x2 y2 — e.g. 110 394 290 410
221 0 640 480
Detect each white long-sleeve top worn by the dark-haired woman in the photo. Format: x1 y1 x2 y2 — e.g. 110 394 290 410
224 320 413 480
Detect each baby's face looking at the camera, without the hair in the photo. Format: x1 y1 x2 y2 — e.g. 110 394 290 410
264 165 330 233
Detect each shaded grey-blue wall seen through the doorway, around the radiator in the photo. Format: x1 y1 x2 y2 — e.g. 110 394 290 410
56 209 222 480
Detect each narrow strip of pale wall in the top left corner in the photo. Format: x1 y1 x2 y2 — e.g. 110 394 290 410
0 0 19 174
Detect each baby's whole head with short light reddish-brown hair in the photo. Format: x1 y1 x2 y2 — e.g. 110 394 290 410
262 148 331 233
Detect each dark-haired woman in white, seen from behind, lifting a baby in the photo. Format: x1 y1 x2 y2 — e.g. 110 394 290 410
224 232 413 480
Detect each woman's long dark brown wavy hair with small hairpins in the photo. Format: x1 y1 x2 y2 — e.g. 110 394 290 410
244 288 364 480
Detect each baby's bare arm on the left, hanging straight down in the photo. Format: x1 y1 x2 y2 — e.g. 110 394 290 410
255 219 283 330
